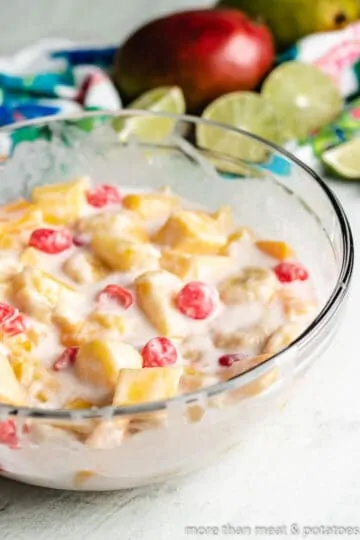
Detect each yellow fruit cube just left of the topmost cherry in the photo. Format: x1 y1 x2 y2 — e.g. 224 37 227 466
32 177 90 224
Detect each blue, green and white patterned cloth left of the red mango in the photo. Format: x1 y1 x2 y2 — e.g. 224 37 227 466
0 40 121 127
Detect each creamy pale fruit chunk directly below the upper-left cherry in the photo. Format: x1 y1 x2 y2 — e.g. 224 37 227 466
11 266 79 320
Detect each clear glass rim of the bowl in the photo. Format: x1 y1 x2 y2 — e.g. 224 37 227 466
0 109 354 421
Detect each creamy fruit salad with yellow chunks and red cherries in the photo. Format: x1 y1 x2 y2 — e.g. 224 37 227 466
0 177 317 446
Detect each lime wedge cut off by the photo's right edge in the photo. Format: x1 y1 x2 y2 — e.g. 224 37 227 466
321 138 360 180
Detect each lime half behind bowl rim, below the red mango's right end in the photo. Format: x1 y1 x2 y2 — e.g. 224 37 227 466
196 92 282 169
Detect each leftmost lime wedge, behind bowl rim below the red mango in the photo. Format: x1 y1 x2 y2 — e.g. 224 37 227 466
113 86 186 142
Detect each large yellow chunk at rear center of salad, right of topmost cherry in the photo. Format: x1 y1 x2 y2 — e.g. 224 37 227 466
153 210 227 255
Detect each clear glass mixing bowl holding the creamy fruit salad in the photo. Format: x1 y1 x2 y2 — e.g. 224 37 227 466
0 110 354 490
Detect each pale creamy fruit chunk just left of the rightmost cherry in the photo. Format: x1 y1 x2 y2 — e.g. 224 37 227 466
219 267 279 304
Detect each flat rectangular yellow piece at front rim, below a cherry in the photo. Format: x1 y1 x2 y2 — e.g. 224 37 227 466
113 367 183 406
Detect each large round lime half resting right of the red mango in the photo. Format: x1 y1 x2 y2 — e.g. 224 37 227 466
261 62 343 140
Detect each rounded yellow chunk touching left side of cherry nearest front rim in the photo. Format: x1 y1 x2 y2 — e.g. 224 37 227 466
75 339 143 392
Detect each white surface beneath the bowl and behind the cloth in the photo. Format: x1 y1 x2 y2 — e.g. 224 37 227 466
0 0 360 540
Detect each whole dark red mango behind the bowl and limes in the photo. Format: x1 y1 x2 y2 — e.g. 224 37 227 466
114 9 275 112
